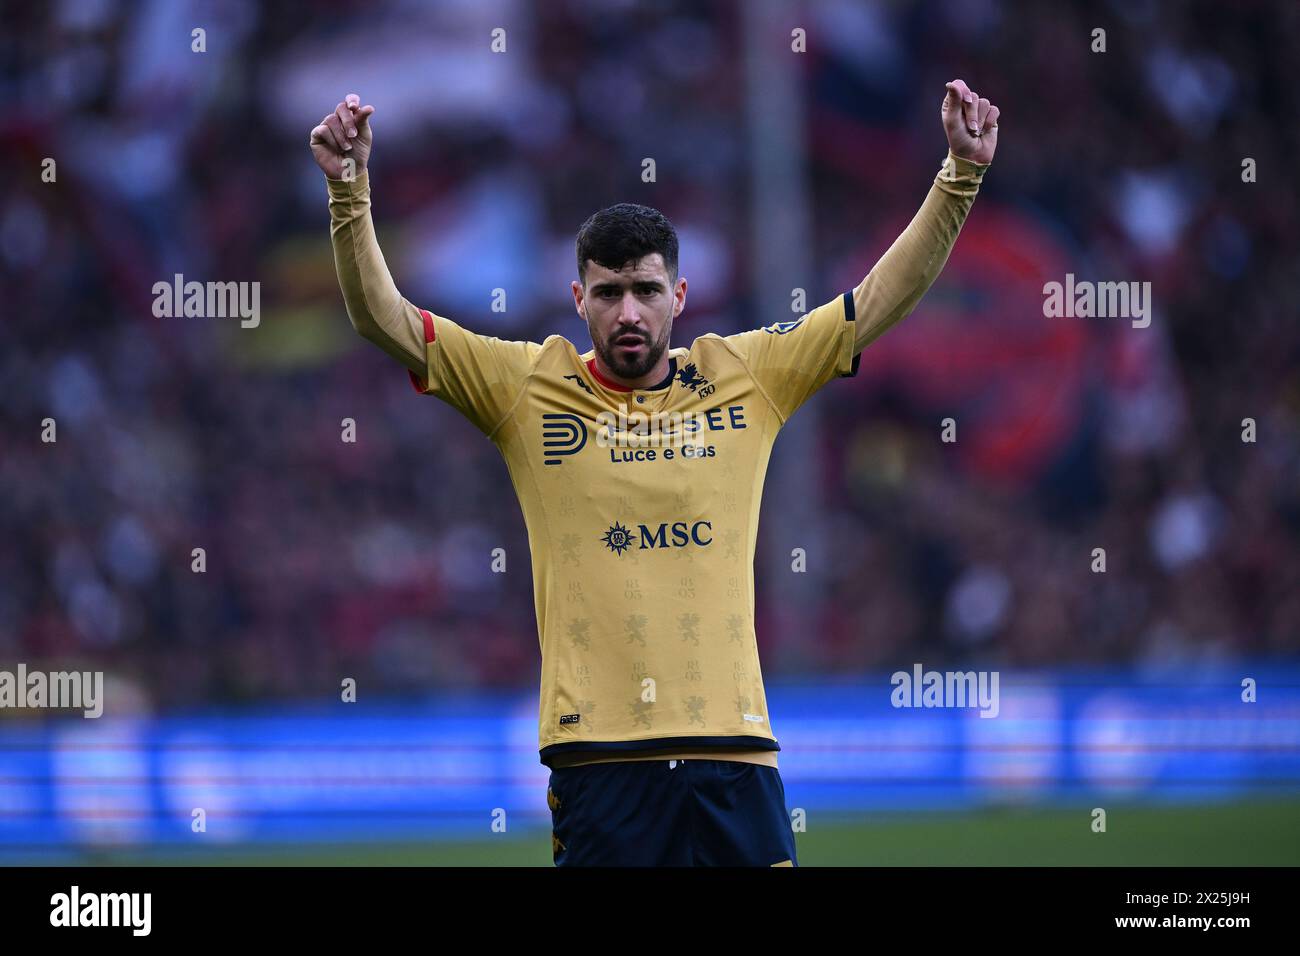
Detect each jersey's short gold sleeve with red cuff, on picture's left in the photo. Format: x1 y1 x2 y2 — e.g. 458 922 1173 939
410 310 542 437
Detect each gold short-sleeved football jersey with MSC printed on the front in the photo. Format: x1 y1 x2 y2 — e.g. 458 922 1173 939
400 293 858 763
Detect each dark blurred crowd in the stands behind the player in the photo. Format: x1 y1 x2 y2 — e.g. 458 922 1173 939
0 0 1300 708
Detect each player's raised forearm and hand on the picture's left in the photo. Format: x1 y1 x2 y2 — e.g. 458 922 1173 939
311 94 425 376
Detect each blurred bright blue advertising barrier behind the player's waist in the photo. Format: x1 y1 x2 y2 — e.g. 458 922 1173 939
0 665 1300 851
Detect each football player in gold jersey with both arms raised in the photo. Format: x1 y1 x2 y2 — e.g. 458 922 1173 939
311 79 998 866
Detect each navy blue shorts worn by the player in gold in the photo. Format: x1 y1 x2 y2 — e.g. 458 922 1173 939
546 758 798 866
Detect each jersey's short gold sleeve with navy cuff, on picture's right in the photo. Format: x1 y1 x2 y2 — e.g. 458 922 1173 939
724 293 858 424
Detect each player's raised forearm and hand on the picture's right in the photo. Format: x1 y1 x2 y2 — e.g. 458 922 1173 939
853 79 998 354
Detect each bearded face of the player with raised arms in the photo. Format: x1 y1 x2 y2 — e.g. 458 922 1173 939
573 252 686 386
